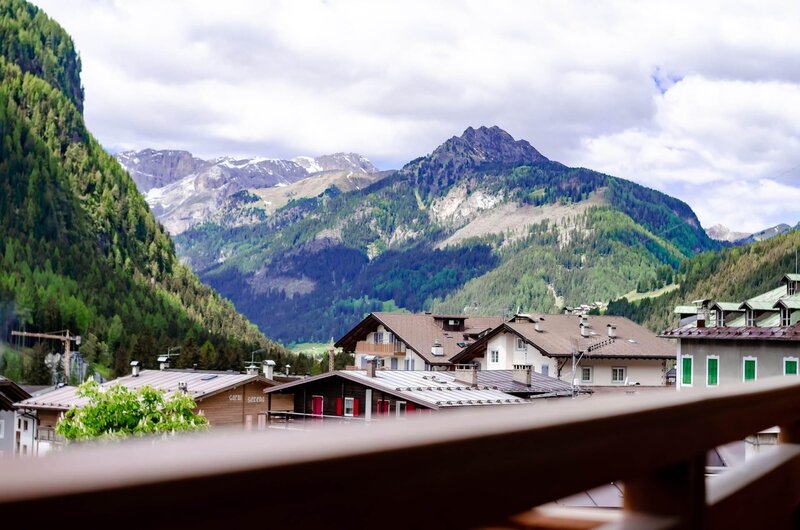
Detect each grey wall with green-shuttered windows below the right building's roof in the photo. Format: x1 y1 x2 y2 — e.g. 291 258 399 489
676 338 800 388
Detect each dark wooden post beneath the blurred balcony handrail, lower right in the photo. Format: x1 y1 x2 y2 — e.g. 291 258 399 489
624 455 706 529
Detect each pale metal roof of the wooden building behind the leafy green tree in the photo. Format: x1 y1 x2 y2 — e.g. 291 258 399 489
14 370 274 410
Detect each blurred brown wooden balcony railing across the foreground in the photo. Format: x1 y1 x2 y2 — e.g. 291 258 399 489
0 377 800 529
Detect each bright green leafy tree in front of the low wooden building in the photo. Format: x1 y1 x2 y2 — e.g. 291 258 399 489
56 381 208 440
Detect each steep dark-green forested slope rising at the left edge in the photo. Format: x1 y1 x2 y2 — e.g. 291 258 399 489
0 0 284 380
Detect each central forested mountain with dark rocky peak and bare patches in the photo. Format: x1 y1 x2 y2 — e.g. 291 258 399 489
176 127 718 341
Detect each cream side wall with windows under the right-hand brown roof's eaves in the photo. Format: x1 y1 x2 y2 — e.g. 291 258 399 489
561 357 667 386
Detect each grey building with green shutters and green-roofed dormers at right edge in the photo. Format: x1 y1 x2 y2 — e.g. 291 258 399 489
661 274 800 389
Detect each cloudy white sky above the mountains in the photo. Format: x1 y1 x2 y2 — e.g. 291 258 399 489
35 0 800 231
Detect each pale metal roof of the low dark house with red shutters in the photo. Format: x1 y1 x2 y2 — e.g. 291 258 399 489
264 370 526 409
